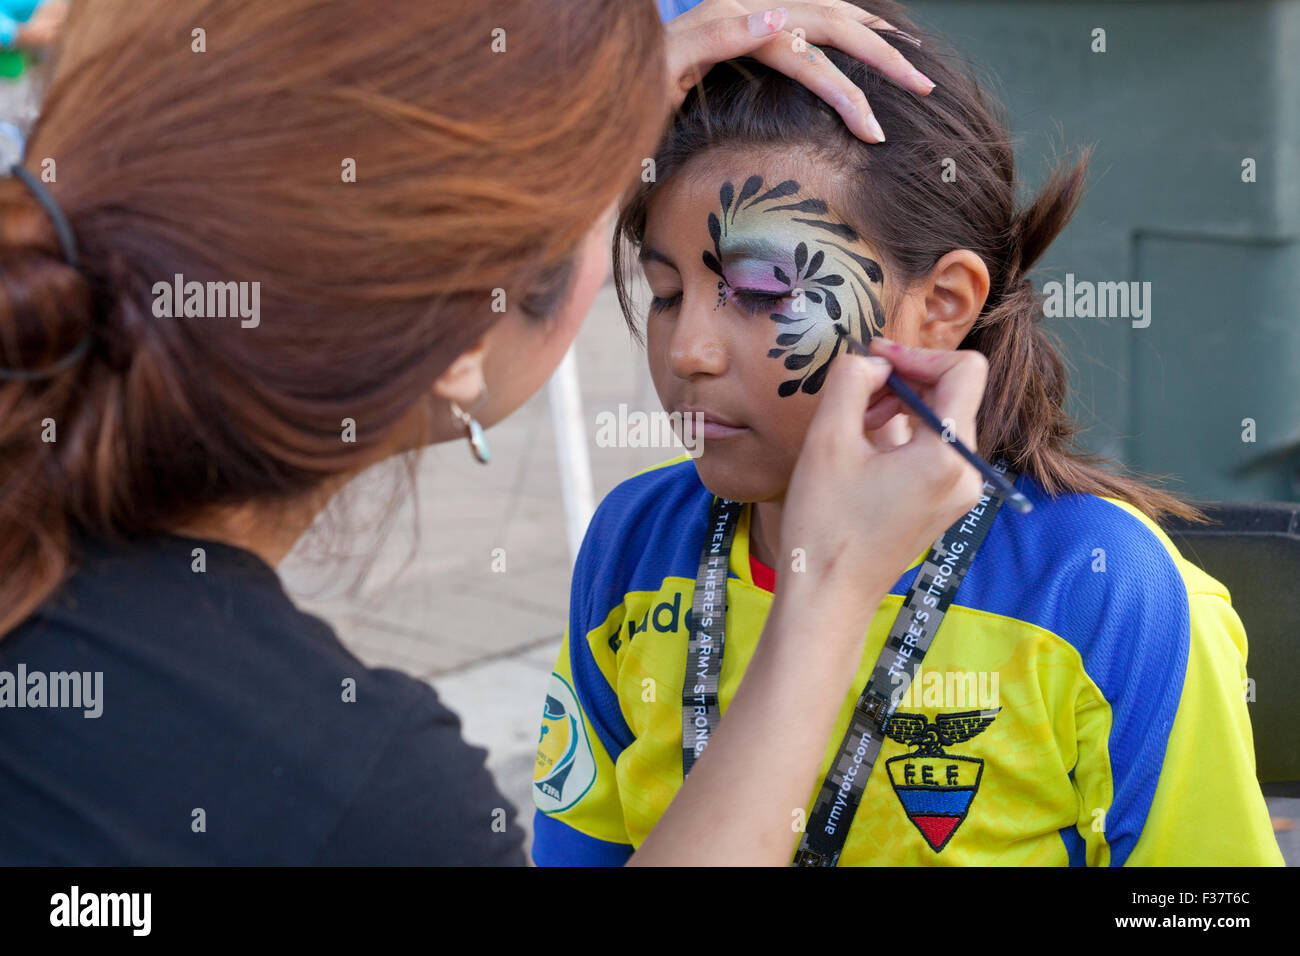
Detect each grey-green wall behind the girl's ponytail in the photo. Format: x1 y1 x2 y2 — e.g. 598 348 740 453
910 0 1300 501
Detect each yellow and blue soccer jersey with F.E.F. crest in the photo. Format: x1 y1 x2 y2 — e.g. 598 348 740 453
533 459 1282 866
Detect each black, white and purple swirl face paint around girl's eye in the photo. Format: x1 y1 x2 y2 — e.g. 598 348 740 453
703 176 884 398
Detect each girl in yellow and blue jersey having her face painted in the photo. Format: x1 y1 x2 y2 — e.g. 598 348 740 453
533 4 1282 865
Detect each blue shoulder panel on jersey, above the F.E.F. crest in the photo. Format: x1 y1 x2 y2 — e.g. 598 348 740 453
891 475 1191 866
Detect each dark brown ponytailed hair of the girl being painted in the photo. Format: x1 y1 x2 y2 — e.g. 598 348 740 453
614 0 1201 520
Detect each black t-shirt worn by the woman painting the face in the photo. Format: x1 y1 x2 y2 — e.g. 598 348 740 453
0 536 524 865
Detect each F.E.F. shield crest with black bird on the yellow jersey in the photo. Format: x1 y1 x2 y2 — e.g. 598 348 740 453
884 708 1001 853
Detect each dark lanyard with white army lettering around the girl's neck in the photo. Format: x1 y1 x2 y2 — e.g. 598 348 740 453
681 462 1015 866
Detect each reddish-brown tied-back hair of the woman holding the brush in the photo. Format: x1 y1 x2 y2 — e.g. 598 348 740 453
0 0 667 642
